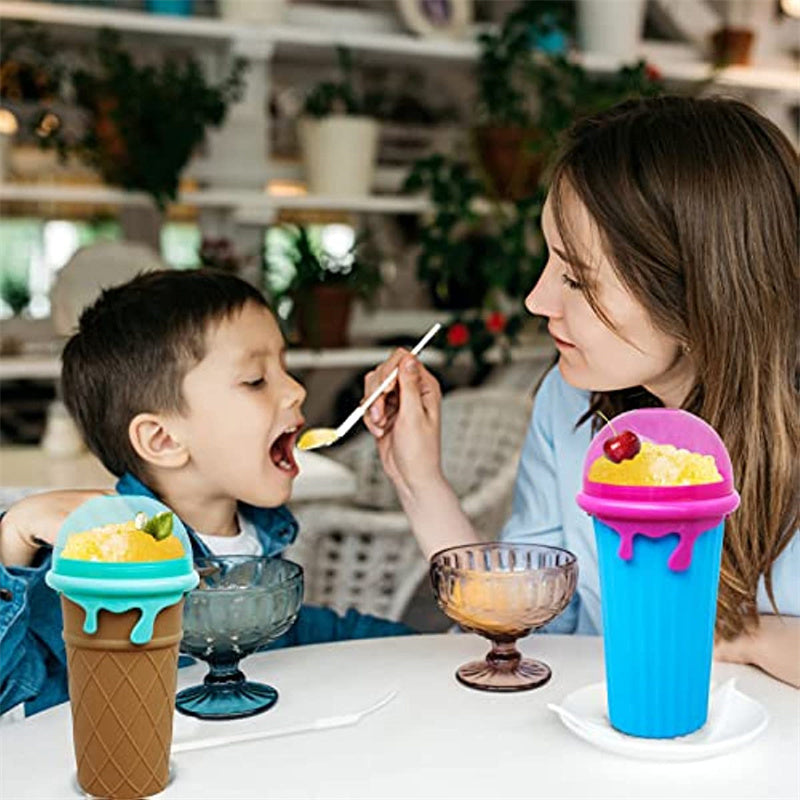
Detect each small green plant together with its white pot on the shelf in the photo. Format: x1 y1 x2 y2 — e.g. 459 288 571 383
298 47 378 197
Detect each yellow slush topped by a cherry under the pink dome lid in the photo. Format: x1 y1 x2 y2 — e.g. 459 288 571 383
589 442 722 486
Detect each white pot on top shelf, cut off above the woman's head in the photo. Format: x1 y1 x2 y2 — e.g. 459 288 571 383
578 0 646 61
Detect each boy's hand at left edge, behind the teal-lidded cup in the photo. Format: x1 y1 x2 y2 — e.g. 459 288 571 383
0 489 110 567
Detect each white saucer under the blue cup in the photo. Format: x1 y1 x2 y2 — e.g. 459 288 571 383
548 680 769 761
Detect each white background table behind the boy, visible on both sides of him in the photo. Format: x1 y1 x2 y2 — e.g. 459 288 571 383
0 445 356 507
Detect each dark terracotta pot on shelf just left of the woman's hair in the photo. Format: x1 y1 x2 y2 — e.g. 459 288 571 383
475 127 547 200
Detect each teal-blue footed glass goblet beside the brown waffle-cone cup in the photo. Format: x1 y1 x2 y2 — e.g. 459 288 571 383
175 556 303 719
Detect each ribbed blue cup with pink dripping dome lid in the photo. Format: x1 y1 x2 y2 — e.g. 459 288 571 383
577 409 739 738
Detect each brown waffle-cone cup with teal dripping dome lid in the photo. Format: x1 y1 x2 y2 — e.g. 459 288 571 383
47 497 197 800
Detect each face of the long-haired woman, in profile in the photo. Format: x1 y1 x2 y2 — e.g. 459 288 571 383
525 188 693 406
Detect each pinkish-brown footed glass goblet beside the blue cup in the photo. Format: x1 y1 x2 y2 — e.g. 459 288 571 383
430 542 578 692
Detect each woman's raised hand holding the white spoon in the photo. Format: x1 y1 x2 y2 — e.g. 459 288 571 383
364 349 443 499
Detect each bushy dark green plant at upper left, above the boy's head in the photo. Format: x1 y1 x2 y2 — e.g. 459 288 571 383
39 30 246 209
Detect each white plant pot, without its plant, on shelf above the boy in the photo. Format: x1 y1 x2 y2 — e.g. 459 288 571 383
298 115 378 197
